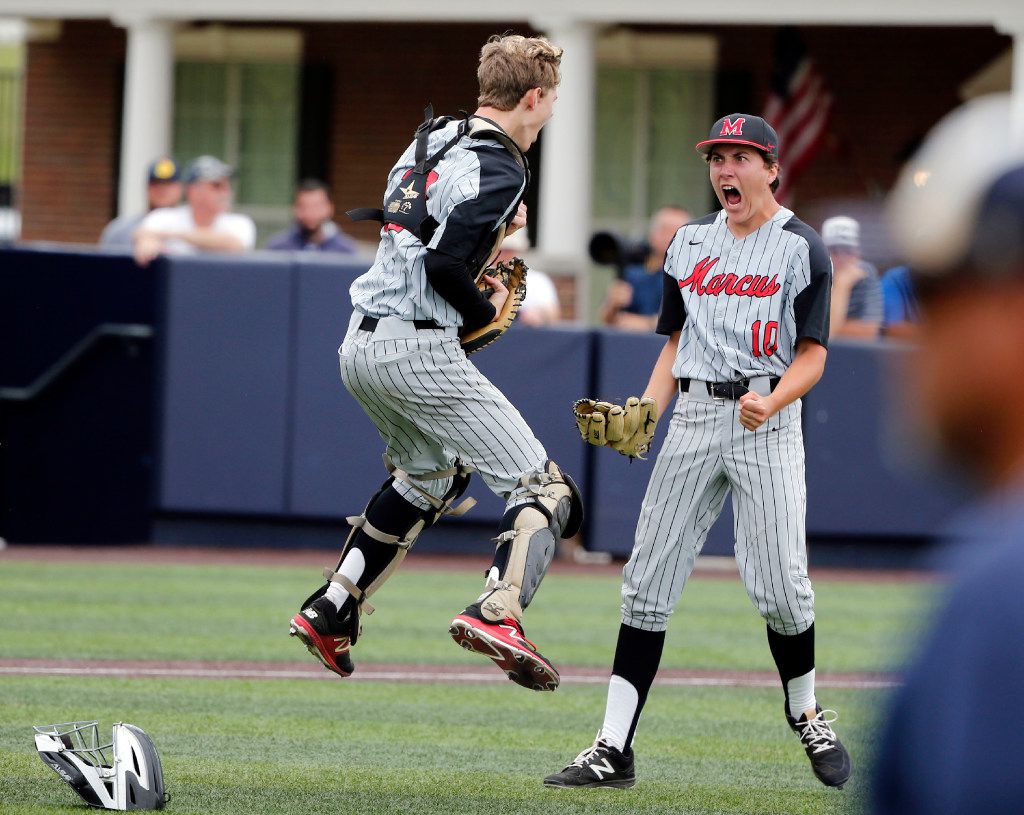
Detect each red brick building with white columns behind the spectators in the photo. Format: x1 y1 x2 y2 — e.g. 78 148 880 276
6 6 1024 311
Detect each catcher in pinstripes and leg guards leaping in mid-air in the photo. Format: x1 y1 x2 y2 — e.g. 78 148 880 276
290 35 583 690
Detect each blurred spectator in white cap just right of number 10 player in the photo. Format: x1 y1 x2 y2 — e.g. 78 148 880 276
821 215 882 339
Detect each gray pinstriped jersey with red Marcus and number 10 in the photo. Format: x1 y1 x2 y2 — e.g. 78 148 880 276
657 207 831 382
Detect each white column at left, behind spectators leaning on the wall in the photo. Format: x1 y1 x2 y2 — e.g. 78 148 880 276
114 18 174 215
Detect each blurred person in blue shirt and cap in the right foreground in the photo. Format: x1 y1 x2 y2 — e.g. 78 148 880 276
873 94 1024 815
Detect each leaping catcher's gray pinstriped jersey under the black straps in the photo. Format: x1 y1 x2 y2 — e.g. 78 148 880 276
349 122 526 327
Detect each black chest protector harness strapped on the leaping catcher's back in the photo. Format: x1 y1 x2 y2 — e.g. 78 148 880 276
346 104 529 259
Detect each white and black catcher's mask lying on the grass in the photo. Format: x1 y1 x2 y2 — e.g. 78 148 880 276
33 722 168 810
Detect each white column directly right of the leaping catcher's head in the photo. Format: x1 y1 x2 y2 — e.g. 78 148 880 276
534 18 595 321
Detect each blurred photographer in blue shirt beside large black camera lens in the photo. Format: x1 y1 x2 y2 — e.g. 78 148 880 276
601 207 690 332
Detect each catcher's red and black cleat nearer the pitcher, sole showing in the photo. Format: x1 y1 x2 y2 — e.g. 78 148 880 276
449 603 559 690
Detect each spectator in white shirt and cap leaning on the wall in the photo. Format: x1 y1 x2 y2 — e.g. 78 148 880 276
134 156 256 266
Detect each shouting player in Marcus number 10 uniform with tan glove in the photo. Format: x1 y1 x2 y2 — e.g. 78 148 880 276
544 114 850 787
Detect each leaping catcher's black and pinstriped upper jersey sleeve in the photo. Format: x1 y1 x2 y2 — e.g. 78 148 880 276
428 146 526 262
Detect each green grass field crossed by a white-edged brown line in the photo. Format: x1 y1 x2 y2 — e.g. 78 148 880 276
0 555 932 815
